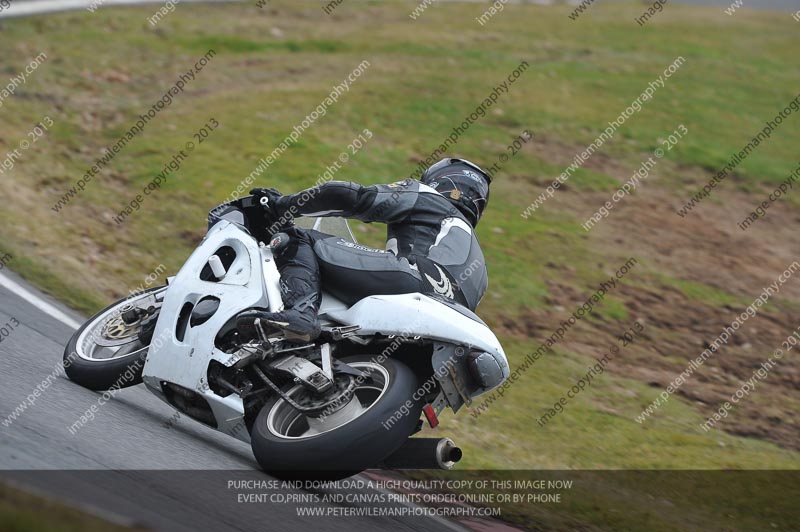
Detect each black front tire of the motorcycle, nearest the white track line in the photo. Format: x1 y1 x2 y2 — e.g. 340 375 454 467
64 287 164 391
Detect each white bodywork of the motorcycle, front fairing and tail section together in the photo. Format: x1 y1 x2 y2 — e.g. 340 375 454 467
143 216 509 442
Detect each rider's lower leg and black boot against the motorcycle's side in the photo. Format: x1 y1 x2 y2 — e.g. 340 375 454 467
236 231 320 342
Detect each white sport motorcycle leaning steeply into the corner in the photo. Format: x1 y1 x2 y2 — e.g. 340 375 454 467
64 196 509 479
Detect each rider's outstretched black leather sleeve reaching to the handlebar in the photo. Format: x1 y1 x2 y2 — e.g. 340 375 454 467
280 179 419 223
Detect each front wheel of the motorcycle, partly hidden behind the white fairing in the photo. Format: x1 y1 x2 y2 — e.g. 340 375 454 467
64 286 166 390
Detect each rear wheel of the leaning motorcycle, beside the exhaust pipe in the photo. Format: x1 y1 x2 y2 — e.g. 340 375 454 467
251 356 422 479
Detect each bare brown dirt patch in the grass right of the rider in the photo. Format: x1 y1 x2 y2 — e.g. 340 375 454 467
506 137 800 449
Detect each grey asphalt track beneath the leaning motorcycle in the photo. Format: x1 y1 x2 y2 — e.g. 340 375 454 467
0 270 482 532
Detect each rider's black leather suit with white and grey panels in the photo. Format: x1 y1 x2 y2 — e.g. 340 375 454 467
276 179 488 310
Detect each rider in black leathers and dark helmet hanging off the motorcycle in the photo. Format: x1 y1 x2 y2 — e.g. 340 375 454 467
237 158 491 341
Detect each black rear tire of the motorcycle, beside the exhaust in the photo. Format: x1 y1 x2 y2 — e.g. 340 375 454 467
251 356 422 480
